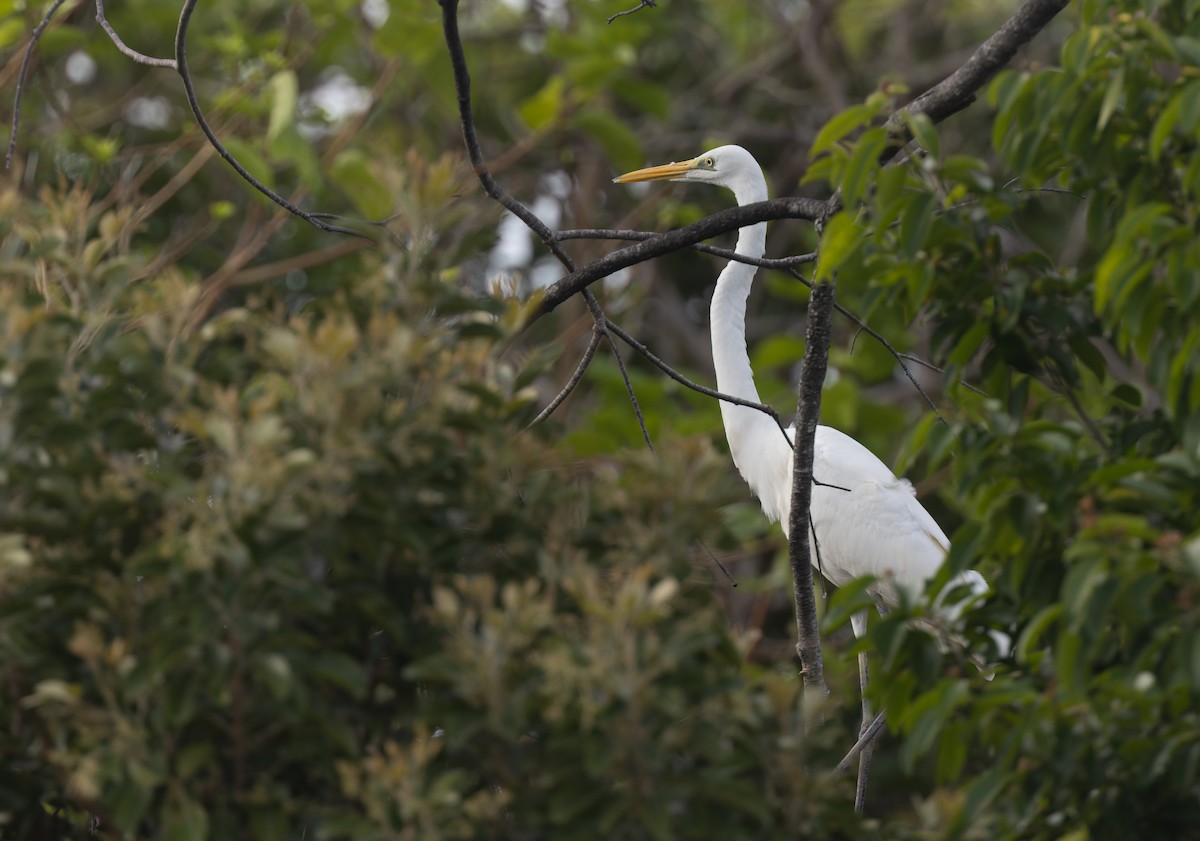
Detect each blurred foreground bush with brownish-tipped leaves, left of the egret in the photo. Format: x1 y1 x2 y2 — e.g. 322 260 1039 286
0 187 864 839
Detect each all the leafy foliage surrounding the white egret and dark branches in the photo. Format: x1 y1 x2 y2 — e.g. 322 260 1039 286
0 0 1200 841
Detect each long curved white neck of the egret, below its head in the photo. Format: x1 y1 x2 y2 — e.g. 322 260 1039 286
710 176 791 519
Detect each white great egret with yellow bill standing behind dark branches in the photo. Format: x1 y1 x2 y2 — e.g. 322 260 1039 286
613 146 988 809
